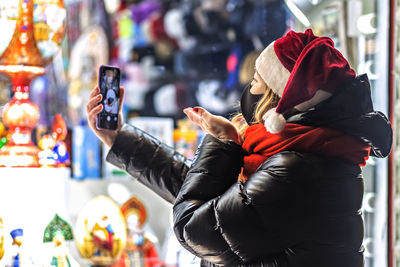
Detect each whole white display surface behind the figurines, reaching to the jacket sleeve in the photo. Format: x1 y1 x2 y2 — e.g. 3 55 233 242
0 168 172 266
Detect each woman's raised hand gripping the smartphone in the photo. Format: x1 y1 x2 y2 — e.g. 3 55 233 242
86 87 125 147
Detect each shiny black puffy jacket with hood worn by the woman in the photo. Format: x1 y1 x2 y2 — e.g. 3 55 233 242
107 76 392 267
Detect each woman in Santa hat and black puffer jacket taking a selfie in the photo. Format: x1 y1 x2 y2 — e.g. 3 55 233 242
87 30 392 267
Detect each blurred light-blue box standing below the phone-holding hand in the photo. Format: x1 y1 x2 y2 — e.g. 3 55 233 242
72 126 101 180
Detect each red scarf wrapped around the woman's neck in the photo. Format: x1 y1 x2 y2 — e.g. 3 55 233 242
242 123 371 180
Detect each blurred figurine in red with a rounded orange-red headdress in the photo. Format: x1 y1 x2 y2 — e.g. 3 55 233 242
112 197 163 267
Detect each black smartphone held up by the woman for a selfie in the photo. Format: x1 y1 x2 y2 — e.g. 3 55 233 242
96 65 120 130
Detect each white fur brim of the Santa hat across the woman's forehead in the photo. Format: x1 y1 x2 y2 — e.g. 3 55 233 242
256 41 290 97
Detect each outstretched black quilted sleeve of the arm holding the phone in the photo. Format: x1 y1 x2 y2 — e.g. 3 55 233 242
106 124 191 203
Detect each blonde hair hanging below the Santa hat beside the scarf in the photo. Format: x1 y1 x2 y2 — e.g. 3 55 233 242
231 86 280 140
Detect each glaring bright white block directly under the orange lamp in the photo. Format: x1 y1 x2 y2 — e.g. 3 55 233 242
0 168 70 264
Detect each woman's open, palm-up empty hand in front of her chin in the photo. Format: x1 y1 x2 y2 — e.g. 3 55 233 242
183 107 241 144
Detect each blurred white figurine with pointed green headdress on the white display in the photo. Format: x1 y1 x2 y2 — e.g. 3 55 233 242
43 214 79 267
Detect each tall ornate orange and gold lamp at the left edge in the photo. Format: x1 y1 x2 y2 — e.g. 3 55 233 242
0 0 66 167
